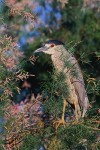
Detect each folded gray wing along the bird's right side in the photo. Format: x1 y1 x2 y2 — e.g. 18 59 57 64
70 53 89 117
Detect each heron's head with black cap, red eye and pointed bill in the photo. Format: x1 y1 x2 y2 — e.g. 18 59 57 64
34 40 64 55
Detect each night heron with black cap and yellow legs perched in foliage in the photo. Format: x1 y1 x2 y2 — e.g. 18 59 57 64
33 40 89 128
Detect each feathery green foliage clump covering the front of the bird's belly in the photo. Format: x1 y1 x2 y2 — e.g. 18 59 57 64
42 71 68 118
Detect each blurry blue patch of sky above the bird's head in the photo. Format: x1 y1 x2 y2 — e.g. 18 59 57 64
20 0 62 46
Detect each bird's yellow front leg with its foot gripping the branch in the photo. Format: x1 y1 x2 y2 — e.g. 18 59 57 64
53 99 67 130
